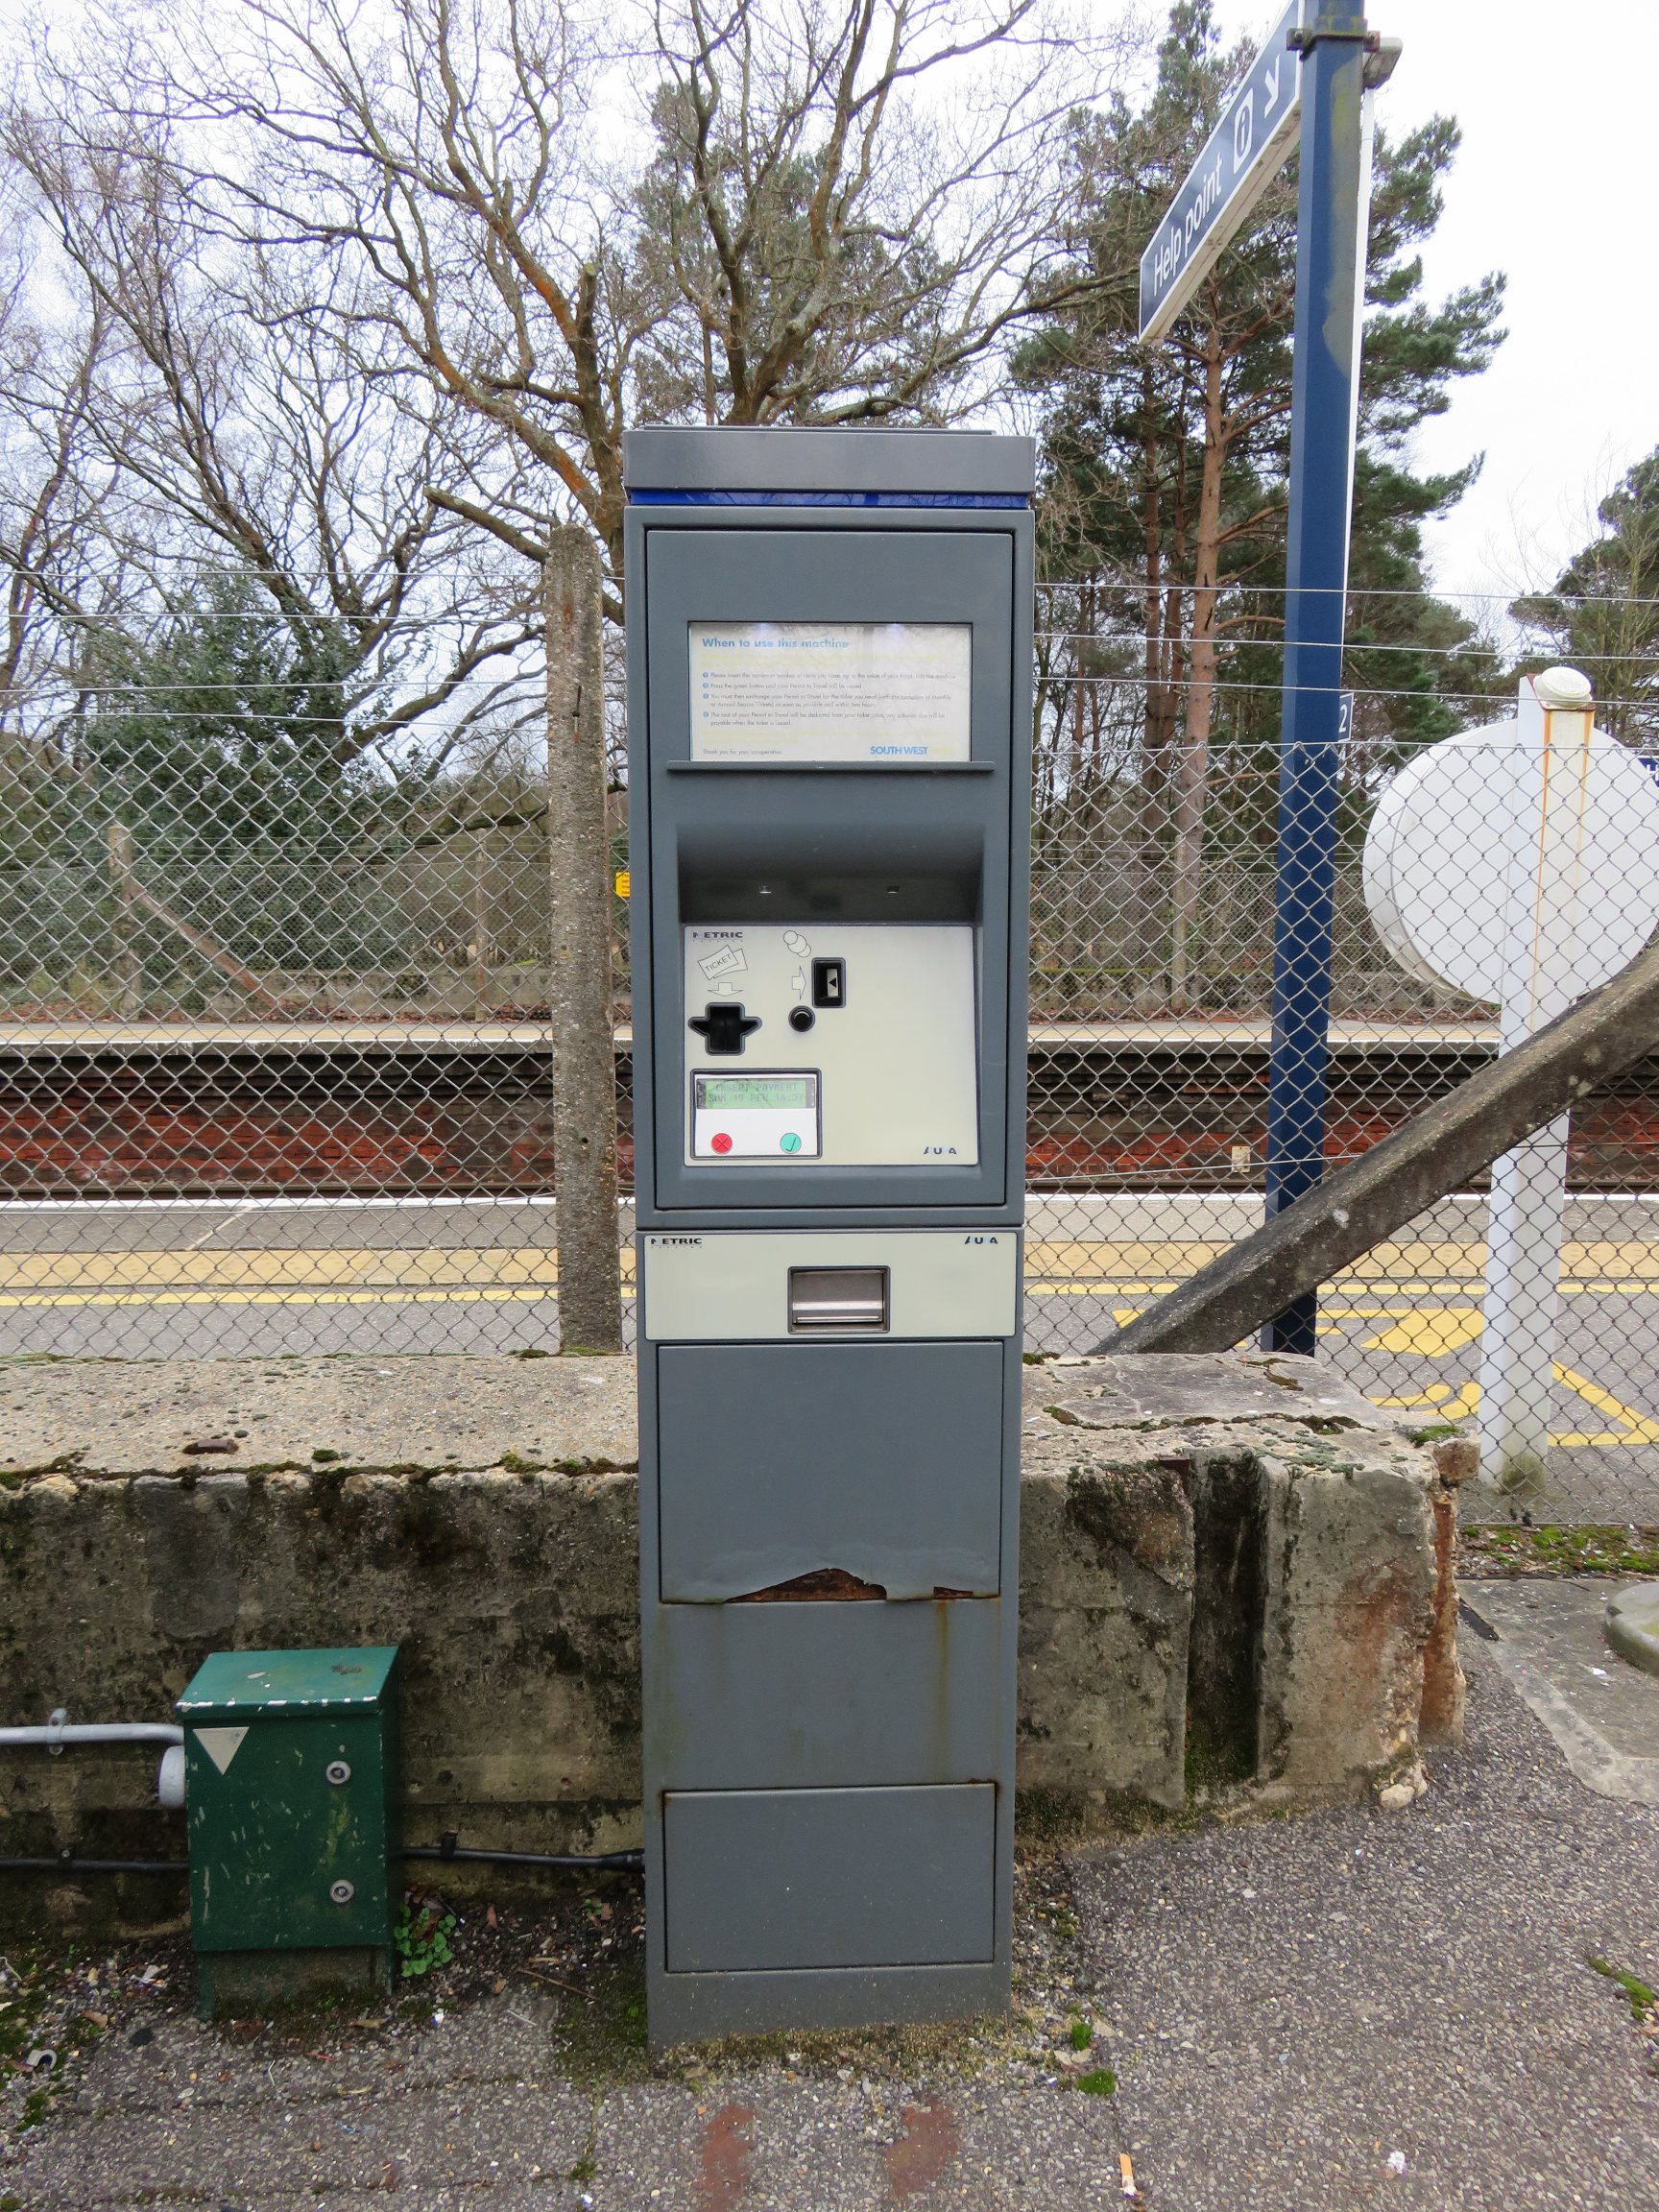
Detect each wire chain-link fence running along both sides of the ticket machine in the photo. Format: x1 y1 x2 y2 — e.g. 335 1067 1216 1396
0 589 1659 1522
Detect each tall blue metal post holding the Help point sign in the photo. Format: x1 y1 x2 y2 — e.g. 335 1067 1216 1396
1261 0 1369 1352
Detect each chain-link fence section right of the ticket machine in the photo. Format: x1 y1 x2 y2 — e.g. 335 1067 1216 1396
1026 587 1659 1524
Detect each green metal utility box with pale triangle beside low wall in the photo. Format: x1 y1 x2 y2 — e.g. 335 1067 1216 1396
175 1644 402 2013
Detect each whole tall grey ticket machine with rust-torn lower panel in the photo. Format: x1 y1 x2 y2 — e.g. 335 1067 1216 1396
624 429 1033 2044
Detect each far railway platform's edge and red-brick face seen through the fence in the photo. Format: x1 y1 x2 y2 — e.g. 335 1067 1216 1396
0 1020 1659 1196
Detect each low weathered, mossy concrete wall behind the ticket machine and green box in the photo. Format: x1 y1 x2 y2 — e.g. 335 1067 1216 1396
0 1354 1460 1929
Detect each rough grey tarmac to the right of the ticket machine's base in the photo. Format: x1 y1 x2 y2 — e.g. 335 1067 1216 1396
1072 1639 1659 2212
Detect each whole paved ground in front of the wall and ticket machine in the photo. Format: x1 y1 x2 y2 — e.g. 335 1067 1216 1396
0 1646 1659 2212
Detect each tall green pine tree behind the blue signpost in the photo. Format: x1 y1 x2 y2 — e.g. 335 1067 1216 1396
1018 0 1502 1006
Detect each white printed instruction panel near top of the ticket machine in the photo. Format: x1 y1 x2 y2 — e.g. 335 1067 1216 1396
690 621 974 767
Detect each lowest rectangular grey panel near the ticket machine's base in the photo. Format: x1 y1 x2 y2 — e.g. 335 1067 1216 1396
663 1783 996 1975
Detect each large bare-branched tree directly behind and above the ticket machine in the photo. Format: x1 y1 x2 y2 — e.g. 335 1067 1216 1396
97 0 1126 1340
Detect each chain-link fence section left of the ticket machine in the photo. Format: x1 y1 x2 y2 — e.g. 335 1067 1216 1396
0 708 626 1358
